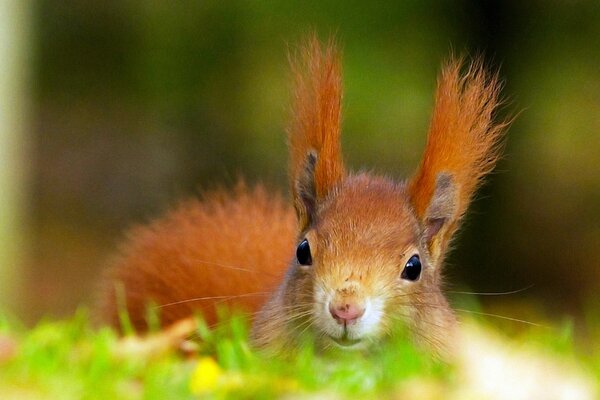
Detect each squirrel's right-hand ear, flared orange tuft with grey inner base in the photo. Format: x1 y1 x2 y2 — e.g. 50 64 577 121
408 55 508 263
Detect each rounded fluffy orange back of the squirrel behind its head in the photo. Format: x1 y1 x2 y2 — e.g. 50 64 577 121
102 185 297 331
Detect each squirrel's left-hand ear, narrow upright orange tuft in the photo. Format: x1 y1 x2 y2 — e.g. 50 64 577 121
288 34 345 231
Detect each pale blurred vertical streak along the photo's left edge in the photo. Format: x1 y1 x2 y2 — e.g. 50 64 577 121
0 0 32 318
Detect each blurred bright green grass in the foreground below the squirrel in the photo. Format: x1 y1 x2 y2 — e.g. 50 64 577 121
0 310 600 399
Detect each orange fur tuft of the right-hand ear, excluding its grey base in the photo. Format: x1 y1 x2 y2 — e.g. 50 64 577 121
409 59 508 225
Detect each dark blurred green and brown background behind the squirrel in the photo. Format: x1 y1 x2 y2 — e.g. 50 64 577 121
0 0 600 332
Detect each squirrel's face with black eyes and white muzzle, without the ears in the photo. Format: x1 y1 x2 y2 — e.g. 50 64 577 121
293 174 452 348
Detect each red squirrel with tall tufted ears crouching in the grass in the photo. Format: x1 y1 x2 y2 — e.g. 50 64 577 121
101 36 508 355
